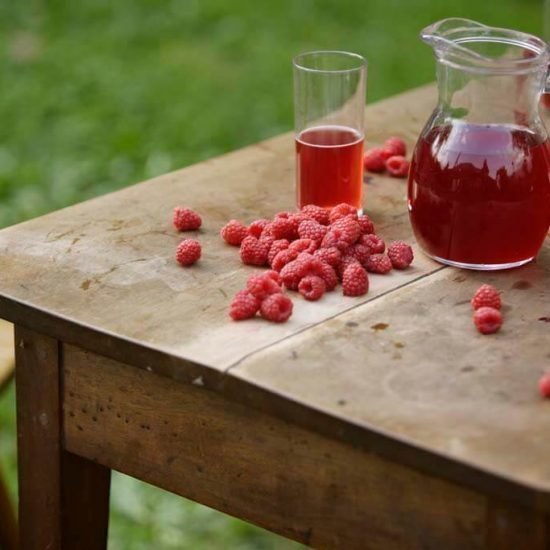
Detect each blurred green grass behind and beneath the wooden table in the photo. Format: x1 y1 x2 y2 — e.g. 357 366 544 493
0 0 543 550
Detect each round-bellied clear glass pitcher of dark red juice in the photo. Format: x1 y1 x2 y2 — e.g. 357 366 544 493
408 18 550 270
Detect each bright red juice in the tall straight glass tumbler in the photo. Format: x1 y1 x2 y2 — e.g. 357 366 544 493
296 126 363 210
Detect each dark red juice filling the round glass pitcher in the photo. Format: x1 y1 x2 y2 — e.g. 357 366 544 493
408 122 550 269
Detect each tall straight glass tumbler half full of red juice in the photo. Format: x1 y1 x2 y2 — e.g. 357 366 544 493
294 51 367 212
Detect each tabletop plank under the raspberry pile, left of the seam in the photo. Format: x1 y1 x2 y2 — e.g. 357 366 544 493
0 88 438 377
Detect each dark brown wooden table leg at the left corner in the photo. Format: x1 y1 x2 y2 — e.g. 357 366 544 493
15 326 110 550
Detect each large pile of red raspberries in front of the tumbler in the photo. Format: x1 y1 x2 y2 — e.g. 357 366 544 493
220 203 413 322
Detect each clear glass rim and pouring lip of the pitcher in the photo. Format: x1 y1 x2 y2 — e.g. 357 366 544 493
420 17 550 74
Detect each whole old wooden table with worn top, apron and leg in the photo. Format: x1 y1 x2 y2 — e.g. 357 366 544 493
0 87 550 550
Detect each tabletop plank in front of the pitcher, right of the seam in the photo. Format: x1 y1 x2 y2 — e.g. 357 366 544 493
230 248 550 511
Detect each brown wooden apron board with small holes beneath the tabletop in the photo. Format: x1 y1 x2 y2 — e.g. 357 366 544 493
64 346 492 550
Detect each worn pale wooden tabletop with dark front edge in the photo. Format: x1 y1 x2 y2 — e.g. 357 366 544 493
0 86 550 510
